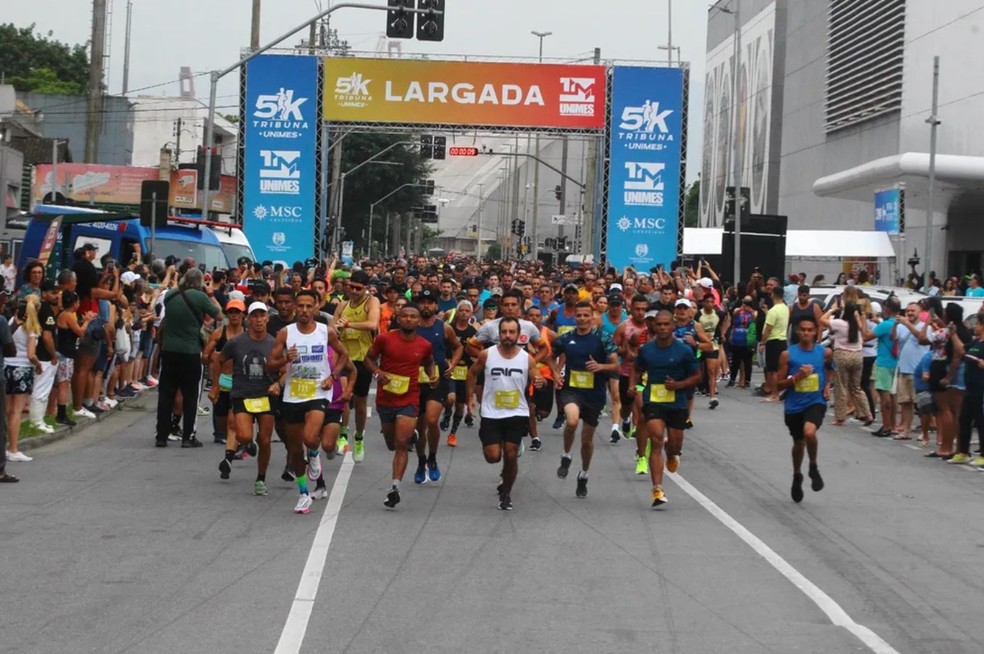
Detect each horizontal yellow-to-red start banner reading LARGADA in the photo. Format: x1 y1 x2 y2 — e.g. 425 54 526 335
324 57 605 129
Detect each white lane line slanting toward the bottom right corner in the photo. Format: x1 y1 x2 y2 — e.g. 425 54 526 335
668 474 899 654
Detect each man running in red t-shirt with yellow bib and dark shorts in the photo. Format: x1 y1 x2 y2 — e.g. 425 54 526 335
365 304 440 509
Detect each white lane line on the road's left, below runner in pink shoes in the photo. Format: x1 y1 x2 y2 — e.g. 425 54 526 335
274 453 355 654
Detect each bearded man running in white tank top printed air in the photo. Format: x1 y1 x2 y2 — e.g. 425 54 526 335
466 318 547 511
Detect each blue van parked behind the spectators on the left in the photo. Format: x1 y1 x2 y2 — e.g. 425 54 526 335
17 205 236 275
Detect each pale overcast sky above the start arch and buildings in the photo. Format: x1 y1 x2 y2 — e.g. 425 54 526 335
0 0 709 179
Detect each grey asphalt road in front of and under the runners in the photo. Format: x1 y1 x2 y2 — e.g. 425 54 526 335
0 391 984 654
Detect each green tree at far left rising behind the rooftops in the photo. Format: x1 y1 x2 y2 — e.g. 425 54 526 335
0 23 89 94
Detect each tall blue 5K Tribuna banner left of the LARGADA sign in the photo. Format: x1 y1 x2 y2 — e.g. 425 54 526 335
242 55 319 264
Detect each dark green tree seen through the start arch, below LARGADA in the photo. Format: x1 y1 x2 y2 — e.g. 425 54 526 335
340 132 431 255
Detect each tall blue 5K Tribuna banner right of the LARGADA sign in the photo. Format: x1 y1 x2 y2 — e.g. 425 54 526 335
607 66 683 270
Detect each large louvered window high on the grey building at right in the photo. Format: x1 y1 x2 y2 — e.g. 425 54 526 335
826 0 905 134
